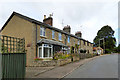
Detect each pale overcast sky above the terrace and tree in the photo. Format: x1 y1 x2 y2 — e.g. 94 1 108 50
0 0 119 45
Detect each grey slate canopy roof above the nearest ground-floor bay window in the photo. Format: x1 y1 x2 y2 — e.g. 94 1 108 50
37 39 67 47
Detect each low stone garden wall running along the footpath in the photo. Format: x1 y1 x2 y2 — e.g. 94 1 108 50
30 54 95 67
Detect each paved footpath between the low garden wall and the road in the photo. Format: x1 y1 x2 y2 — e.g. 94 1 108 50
26 56 99 78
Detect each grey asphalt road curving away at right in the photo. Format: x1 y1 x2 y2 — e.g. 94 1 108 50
65 54 118 78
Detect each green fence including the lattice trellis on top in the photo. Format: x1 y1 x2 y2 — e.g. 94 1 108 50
0 35 26 79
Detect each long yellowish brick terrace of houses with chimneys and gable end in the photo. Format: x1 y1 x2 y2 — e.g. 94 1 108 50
1 12 93 66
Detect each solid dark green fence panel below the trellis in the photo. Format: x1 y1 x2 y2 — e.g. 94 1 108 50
1 53 26 79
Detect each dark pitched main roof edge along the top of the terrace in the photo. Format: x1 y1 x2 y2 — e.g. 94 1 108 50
0 12 93 44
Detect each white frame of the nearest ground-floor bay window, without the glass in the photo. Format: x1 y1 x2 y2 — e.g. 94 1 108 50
38 44 53 58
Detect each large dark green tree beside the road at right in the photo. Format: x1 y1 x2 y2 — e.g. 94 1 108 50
94 25 116 51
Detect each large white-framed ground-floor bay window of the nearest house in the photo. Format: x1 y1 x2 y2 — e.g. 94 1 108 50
38 44 53 58
